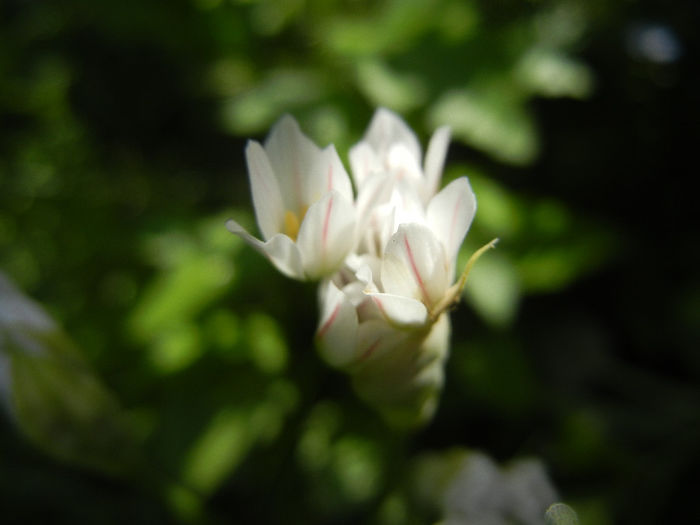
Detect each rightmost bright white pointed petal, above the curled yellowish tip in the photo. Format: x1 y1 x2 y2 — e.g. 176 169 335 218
427 177 476 264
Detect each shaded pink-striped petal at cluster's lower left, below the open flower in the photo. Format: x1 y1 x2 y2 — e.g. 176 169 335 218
316 281 358 367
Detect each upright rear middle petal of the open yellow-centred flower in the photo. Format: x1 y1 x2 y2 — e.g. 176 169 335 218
265 115 321 212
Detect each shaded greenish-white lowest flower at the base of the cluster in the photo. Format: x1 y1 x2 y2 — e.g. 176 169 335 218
316 276 450 426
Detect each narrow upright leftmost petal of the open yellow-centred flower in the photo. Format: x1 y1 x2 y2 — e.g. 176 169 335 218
245 141 284 239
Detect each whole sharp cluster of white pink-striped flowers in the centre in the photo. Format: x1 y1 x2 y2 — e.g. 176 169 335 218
227 109 493 424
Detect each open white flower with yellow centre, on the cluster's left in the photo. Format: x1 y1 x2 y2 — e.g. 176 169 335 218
227 115 355 279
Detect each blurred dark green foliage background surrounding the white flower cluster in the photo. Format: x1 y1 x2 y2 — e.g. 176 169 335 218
0 0 700 525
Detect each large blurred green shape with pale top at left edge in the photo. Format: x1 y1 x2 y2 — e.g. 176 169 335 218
0 273 139 474
